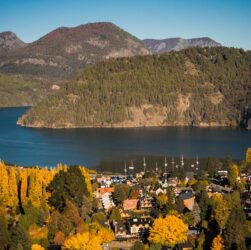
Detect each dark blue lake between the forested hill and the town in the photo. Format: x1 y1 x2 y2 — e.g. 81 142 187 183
0 108 251 171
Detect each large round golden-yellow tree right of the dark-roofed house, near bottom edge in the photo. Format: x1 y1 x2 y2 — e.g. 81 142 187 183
148 215 188 247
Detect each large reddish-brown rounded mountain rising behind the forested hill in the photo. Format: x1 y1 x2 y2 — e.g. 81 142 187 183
0 22 149 83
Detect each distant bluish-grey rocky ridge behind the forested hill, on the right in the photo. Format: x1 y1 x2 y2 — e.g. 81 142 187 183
143 37 221 54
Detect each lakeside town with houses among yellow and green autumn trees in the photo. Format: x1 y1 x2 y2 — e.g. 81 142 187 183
0 148 251 250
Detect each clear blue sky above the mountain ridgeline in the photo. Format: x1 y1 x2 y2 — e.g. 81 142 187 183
0 0 251 49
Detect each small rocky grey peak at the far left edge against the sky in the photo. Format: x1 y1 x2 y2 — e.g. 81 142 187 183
0 31 26 54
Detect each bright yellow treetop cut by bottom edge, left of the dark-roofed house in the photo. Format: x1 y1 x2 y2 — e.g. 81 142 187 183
62 232 101 250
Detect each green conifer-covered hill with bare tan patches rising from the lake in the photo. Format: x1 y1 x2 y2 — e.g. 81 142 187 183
18 47 251 128
